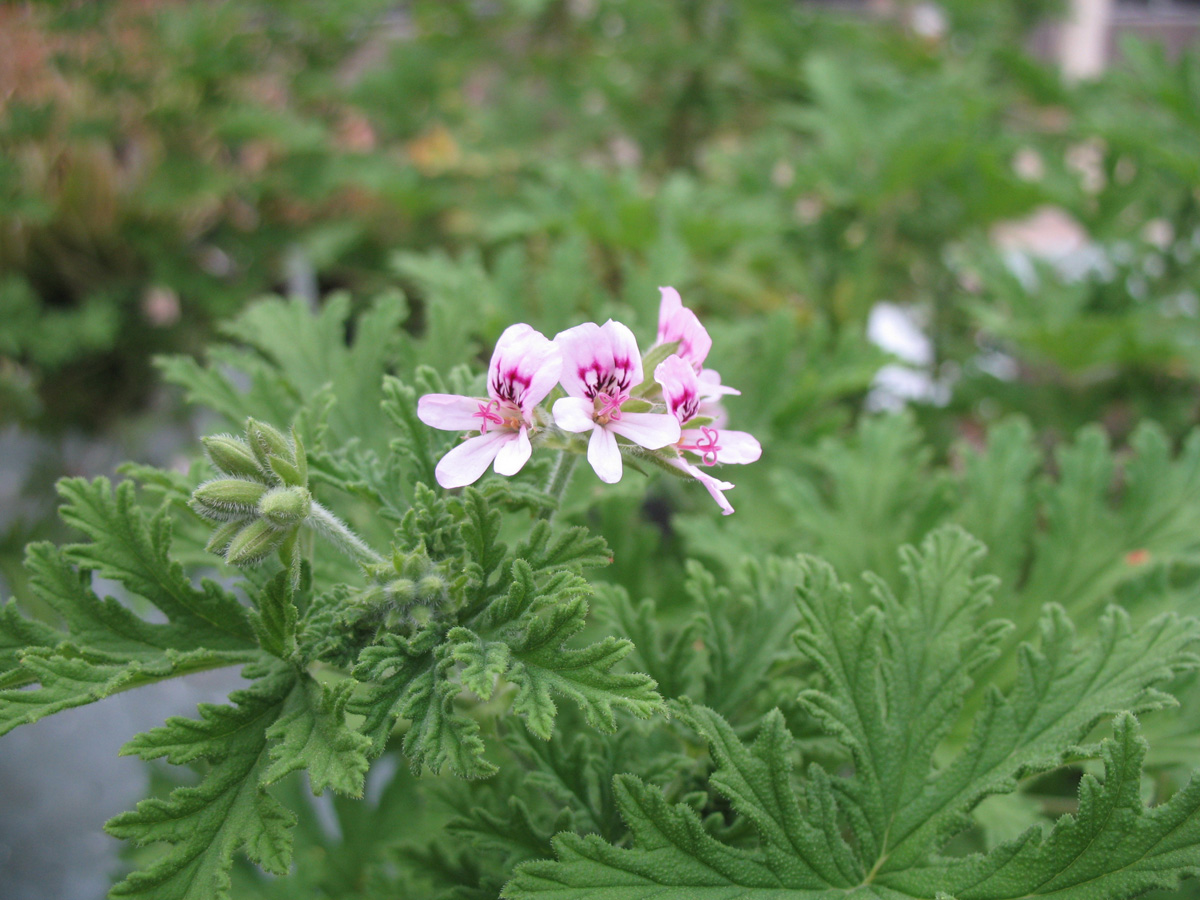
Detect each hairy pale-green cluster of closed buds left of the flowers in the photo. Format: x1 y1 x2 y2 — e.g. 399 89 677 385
191 419 313 571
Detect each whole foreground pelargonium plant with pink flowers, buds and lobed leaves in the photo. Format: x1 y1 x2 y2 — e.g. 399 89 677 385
0 288 1200 900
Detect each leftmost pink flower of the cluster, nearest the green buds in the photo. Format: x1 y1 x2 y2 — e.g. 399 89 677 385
416 325 563 487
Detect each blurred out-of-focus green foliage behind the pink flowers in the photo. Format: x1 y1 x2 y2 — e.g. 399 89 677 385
0 0 1200 895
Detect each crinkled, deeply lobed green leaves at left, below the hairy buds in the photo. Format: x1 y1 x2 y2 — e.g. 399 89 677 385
0 386 662 898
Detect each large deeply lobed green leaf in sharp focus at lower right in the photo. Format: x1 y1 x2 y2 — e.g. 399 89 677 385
504 529 1200 900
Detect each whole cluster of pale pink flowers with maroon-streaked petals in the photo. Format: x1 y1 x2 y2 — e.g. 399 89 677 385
416 288 762 515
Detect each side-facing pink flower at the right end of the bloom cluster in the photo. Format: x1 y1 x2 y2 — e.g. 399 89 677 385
654 355 762 515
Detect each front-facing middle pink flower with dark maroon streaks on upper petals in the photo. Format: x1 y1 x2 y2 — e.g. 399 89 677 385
553 319 679 485
